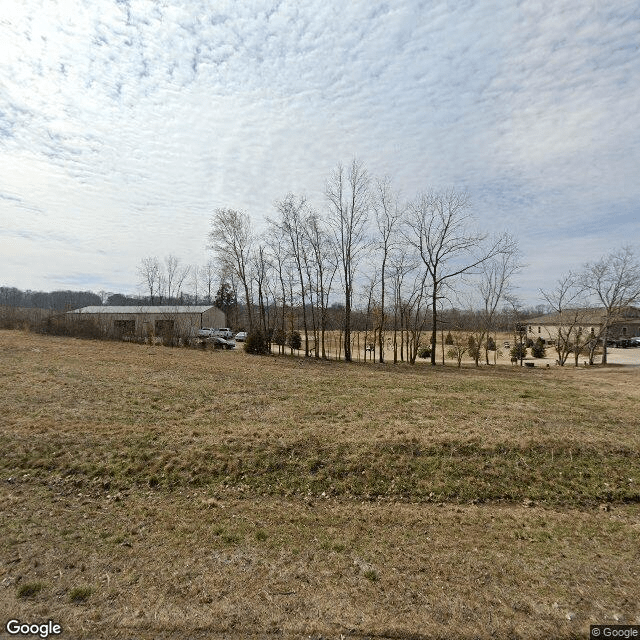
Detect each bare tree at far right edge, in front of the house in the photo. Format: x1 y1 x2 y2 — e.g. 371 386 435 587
581 247 640 364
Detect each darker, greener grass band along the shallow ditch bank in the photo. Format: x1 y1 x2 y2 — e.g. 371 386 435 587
2 434 640 507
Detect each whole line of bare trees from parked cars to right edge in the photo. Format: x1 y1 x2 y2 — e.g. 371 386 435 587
209 160 640 365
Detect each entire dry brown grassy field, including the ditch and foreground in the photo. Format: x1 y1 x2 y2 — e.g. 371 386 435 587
0 331 640 640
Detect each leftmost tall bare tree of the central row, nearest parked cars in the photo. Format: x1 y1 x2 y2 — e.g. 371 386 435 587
209 209 253 330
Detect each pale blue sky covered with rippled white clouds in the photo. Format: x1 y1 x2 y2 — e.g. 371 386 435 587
0 0 640 304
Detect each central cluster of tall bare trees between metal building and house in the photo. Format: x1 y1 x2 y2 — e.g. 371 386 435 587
209 160 519 364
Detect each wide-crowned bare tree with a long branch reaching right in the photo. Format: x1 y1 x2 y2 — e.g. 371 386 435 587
407 189 504 365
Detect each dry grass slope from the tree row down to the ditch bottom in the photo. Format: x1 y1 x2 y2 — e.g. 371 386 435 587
0 331 640 506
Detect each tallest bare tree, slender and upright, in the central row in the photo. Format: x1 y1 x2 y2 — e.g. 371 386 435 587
325 159 370 362
